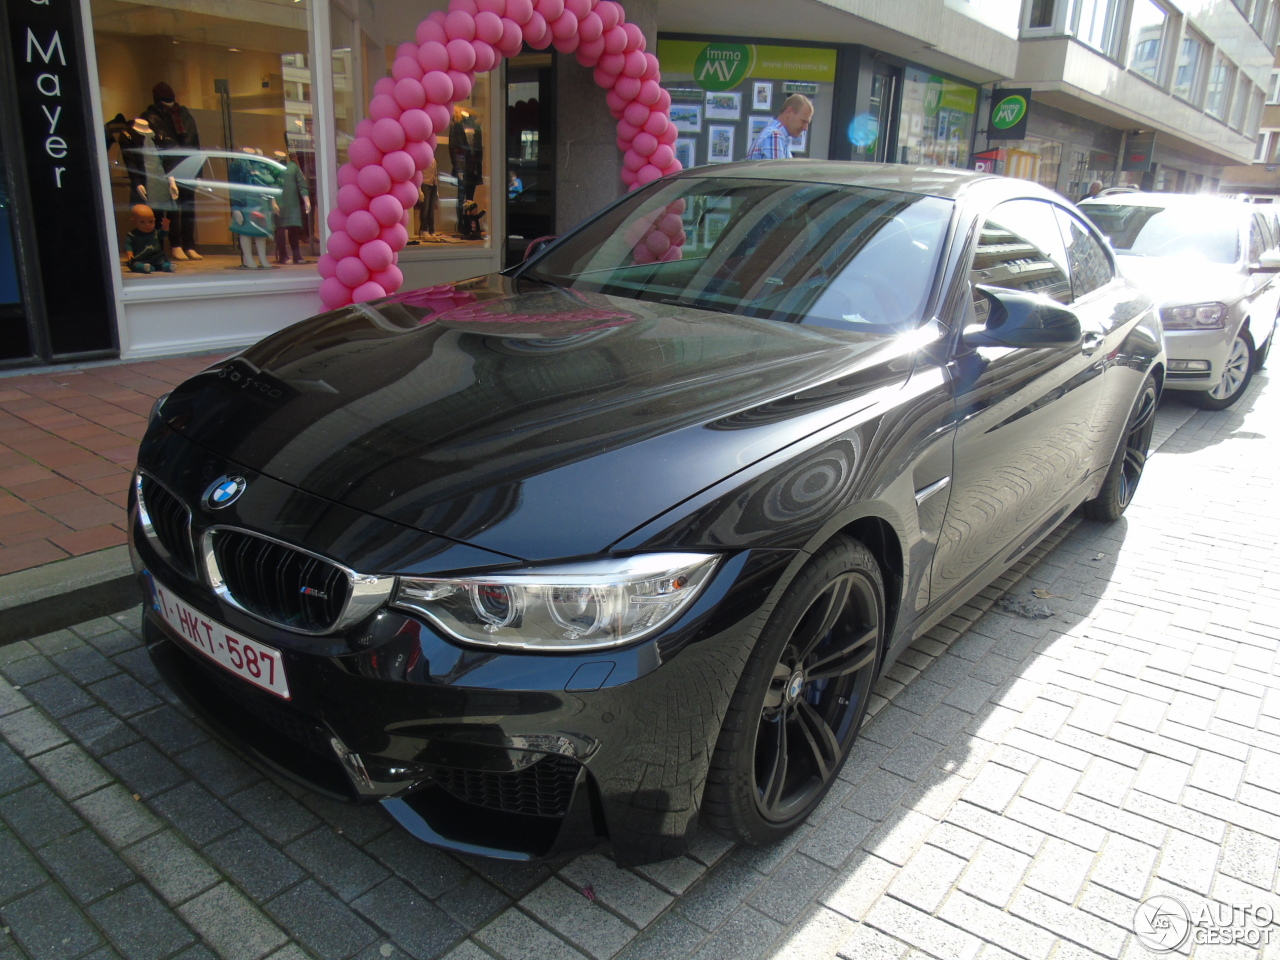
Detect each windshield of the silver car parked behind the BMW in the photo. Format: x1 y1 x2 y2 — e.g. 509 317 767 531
1080 204 1240 264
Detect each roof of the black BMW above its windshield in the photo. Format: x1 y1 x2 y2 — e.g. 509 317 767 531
676 160 1006 200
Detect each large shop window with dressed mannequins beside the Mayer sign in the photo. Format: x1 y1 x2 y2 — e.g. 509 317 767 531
91 0 320 287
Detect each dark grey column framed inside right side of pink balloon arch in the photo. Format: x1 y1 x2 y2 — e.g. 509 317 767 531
556 0 658 233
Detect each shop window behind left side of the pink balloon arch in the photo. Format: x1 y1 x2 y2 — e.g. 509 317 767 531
329 0 498 248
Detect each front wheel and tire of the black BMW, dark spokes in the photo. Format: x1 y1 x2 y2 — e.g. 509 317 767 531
703 536 884 845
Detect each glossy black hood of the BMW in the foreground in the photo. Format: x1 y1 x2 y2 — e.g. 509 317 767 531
161 275 919 559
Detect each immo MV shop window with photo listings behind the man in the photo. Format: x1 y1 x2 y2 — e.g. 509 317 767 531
658 40 839 168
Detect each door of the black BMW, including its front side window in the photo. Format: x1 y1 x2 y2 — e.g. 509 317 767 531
931 198 1108 603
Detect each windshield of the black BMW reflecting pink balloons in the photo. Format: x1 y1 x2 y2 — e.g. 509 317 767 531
521 177 954 333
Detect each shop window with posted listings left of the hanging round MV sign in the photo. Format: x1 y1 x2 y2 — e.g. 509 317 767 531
897 67 978 166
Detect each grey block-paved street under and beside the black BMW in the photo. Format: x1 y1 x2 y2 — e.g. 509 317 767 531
0 378 1280 960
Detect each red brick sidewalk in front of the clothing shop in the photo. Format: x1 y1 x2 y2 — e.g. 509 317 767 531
0 353 225 575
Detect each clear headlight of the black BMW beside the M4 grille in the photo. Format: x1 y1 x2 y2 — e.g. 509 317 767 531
394 553 719 650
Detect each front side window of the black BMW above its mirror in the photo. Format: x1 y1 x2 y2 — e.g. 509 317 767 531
969 200 1071 323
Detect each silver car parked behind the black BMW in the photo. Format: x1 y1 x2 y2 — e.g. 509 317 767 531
1079 193 1280 410
